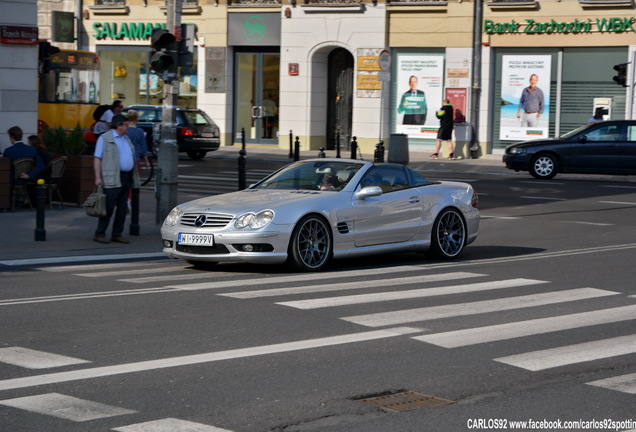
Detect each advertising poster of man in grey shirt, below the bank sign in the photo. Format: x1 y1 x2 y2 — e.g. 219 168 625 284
499 55 551 141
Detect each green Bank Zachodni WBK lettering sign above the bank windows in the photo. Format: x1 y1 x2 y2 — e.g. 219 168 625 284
484 17 636 34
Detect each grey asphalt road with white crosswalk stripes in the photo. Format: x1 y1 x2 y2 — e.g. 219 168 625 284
0 158 636 432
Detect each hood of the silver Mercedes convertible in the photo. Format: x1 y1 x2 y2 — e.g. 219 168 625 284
179 189 336 215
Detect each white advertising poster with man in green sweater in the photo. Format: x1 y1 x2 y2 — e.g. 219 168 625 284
394 54 444 139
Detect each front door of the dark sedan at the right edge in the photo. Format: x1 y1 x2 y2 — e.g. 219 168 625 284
570 123 624 172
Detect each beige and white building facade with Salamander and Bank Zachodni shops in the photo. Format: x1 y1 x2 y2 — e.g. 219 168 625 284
39 0 636 157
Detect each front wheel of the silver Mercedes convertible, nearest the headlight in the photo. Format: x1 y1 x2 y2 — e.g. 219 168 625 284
289 216 333 271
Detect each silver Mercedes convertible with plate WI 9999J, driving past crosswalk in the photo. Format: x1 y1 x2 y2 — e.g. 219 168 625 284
161 159 479 271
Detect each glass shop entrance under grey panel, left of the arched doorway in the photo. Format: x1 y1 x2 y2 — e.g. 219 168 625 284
234 52 280 145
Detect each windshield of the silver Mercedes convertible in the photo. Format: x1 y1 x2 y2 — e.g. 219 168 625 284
253 161 362 192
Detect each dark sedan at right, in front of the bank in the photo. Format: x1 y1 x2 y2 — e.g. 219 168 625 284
503 120 636 179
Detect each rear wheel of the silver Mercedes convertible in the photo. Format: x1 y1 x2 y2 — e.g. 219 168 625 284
429 209 466 259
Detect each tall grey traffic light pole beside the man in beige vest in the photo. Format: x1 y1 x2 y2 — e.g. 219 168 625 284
156 0 181 224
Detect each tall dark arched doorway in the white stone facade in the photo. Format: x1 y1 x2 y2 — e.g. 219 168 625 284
327 48 353 150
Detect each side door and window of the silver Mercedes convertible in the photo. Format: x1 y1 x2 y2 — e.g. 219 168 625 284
353 165 423 247
